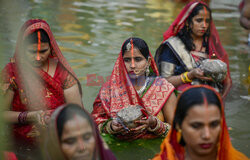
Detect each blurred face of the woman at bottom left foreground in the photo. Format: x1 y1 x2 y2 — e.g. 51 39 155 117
61 115 95 160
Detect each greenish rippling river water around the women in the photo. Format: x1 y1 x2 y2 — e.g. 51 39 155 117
0 0 250 159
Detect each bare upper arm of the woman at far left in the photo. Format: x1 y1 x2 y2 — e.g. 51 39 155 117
64 83 83 107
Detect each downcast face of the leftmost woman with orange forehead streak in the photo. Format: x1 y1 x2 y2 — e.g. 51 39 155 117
25 42 51 67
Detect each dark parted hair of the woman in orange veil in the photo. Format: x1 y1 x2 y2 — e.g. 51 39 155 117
173 87 221 146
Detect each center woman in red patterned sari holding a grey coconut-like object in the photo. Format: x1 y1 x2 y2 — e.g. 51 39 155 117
92 38 176 140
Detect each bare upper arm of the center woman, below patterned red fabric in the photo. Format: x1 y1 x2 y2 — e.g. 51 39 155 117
162 92 176 124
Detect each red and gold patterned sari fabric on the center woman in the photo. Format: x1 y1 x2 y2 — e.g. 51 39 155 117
92 43 174 139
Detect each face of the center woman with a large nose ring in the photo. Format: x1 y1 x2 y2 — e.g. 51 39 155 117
123 48 150 79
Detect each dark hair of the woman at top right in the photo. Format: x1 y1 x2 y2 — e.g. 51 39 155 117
177 3 212 53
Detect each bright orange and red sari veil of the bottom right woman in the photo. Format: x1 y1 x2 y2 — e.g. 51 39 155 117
153 85 248 160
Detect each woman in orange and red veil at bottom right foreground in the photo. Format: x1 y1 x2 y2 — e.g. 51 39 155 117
153 85 248 160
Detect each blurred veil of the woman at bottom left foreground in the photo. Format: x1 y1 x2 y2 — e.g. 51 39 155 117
44 106 116 160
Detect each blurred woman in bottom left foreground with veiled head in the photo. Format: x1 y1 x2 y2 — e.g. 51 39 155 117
44 104 116 160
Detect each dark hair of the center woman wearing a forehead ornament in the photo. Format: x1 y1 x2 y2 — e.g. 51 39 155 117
122 37 149 59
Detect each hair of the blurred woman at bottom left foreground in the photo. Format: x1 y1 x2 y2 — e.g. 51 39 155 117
56 104 94 139
